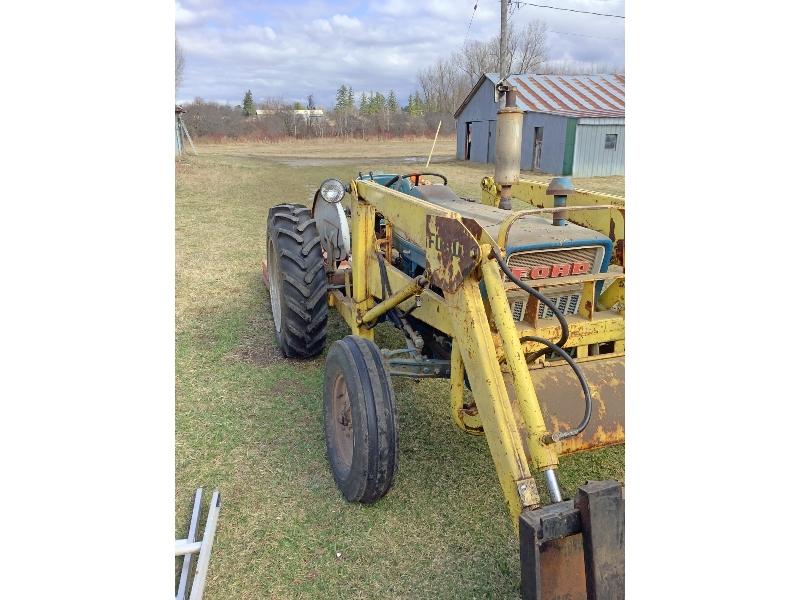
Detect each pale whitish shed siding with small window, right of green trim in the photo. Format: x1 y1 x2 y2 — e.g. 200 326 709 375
572 119 625 177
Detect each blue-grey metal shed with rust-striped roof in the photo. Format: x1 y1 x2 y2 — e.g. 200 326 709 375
454 73 625 177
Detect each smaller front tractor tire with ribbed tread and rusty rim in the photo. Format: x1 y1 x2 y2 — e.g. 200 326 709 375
323 335 398 504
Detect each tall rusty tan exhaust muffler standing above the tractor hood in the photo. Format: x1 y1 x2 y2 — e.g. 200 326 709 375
494 83 523 210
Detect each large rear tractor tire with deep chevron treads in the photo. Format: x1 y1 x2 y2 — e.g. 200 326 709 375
267 204 328 358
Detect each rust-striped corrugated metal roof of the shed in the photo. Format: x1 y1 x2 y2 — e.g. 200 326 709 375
456 73 625 117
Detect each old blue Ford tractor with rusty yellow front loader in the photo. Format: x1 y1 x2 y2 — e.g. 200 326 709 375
262 83 625 600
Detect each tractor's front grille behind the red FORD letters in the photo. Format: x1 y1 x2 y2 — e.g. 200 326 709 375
508 246 603 321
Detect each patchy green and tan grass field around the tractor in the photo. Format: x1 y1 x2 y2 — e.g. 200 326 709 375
175 140 624 600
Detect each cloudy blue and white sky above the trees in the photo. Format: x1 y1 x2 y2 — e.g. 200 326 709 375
175 0 625 106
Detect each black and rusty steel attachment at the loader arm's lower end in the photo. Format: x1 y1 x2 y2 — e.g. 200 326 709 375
519 481 625 600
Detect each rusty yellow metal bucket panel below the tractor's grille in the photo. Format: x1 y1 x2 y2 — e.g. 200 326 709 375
503 356 625 458
